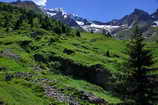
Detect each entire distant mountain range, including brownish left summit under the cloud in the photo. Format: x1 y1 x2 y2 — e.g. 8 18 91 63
9 1 158 39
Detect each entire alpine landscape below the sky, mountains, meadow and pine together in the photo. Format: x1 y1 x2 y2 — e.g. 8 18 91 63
0 0 158 105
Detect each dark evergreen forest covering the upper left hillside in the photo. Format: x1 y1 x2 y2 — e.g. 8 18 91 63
0 3 71 34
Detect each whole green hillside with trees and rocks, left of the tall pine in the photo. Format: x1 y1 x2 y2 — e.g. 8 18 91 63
0 3 158 105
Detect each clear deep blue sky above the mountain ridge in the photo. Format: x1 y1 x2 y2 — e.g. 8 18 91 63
0 0 158 21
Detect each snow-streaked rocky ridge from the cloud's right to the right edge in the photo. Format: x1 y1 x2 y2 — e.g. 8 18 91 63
44 8 158 34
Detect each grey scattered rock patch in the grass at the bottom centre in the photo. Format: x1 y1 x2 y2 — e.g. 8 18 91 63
34 79 108 105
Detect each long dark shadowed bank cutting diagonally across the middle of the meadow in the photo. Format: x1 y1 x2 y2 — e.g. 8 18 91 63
34 54 111 87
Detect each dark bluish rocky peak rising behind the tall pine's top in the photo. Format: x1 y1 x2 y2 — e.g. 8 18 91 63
106 9 158 40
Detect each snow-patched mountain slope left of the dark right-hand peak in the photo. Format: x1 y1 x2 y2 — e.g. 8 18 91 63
44 8 123 33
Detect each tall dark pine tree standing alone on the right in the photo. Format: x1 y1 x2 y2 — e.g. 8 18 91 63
122 27 158 105
